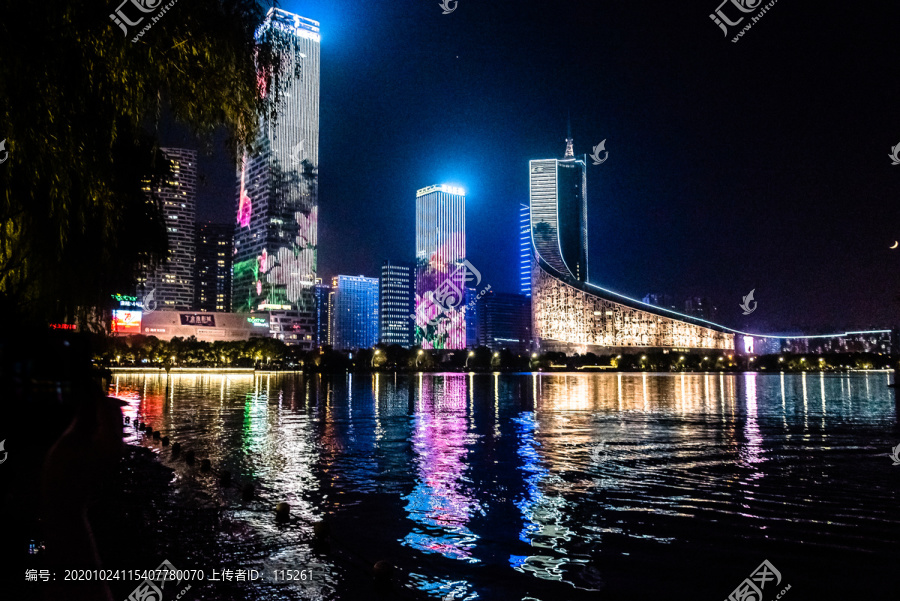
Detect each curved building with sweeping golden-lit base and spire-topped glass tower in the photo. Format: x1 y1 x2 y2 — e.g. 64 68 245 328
529 139 734 353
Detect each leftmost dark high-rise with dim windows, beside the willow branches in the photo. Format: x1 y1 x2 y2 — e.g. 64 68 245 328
137 148 197 311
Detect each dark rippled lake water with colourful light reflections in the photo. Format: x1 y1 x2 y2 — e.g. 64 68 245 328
111 372 900 601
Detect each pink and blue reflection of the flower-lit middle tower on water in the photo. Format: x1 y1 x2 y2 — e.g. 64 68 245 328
403 374 484 563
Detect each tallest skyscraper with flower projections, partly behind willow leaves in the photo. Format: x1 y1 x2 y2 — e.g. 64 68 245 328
232 8 320 350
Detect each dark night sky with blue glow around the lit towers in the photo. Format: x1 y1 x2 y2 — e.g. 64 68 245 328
163 0 900 333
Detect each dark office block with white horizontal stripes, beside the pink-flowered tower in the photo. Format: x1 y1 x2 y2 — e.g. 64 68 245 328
378 260 416 348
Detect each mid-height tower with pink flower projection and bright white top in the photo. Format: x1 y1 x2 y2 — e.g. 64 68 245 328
415 185 468 349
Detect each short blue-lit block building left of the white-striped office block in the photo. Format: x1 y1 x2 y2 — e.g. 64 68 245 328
331 275 378 350
